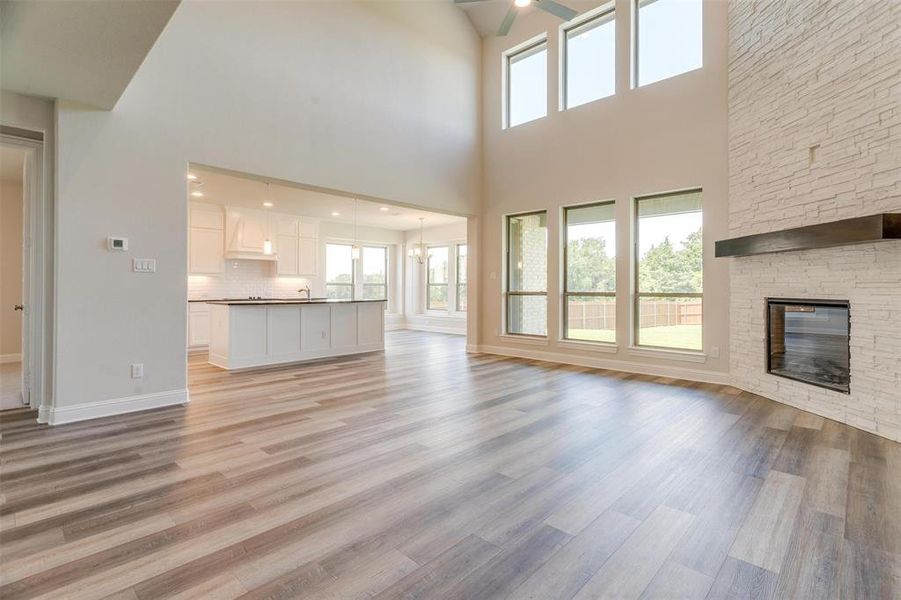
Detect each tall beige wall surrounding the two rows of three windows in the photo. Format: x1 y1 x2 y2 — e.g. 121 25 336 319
479 0 729 381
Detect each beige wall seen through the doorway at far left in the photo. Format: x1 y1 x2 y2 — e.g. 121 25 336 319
0 181 22 359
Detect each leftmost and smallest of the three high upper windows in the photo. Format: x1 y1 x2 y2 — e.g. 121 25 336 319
504 39 547 127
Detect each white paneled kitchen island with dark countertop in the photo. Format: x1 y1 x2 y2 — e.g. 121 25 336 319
208 298 385 369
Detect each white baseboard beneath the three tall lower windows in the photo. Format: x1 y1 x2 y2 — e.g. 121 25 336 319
466 345 734 385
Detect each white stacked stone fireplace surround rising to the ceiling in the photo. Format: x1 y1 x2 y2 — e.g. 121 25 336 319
720 0 901 440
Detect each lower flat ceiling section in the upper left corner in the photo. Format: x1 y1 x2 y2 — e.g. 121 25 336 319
0 0 180 110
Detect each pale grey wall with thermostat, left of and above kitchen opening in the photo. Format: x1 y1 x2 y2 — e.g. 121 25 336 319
56 1 480 407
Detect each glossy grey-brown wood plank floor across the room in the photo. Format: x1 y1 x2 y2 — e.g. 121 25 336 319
0 332 901 600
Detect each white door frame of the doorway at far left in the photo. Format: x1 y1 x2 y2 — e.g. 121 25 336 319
0 126 52 414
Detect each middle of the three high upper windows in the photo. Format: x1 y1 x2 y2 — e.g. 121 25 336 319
561 8 616 108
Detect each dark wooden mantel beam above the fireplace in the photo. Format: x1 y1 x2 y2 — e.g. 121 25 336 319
716 213 901 257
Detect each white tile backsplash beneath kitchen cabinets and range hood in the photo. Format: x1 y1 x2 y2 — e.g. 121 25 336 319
188 260 324 300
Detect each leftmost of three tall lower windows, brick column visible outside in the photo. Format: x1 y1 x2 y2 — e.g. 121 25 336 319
506 211 547 336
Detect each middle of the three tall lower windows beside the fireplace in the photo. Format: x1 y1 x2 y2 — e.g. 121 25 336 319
563 202 616 342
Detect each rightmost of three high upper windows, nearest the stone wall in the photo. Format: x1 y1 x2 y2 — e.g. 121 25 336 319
633 0 704 86
